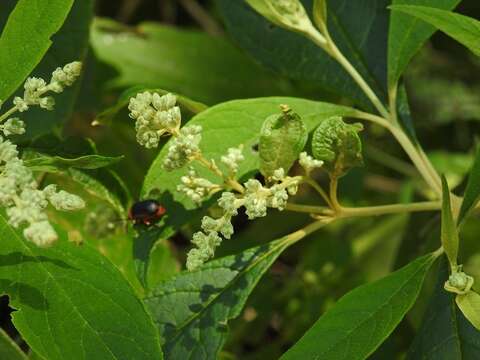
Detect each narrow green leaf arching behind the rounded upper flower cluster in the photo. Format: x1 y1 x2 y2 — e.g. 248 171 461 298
92 86 208 125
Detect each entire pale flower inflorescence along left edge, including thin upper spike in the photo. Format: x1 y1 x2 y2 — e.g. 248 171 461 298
0 62 85 247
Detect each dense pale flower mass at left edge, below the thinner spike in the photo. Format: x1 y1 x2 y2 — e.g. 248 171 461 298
0 138 85 246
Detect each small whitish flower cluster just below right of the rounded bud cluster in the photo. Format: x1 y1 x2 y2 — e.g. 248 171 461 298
163 125 202 171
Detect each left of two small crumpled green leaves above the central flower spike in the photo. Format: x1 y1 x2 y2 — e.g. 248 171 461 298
259 105 308 179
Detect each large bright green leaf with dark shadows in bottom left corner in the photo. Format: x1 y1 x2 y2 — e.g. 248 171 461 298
0 216 162 360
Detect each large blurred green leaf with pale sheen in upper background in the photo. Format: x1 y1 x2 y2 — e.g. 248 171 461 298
91 20 289 104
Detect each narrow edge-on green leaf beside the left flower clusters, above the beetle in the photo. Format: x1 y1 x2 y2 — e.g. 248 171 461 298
24 153 124 172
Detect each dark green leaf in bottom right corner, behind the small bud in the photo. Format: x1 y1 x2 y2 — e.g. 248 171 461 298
407 261 480 360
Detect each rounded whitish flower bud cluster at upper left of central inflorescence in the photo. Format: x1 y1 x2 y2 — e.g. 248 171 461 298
128 91 182 148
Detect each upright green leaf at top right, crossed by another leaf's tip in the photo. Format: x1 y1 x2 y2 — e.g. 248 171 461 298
388 0 461 89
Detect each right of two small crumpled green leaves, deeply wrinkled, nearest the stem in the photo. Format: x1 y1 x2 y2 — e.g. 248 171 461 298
312 116 363 177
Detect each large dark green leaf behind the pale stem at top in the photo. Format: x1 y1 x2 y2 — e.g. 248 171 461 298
216 0 390 107
